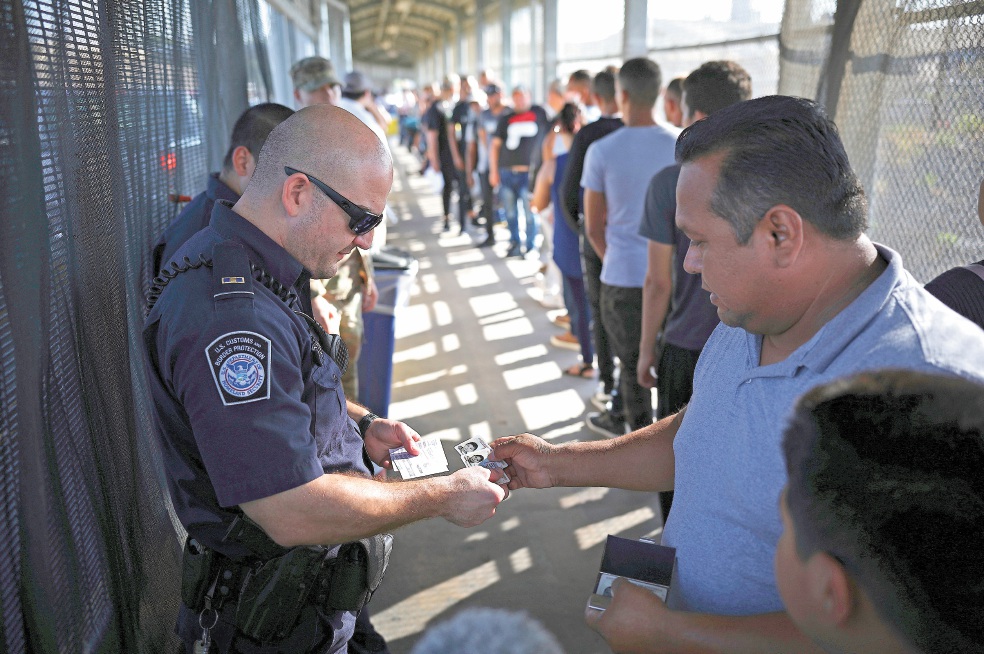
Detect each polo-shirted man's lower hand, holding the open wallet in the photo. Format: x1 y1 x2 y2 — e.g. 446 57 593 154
584 579 674 653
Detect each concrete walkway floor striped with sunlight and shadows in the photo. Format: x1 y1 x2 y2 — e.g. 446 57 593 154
368 146 661 654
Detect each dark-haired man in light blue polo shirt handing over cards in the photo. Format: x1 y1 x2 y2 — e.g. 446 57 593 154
492 96 984 652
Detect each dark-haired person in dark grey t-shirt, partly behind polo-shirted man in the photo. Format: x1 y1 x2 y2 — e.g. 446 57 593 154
636 61 752 522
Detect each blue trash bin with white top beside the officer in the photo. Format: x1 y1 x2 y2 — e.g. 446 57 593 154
359 247 417 418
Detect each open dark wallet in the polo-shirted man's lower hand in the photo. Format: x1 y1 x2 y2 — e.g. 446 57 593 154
588 535 676 611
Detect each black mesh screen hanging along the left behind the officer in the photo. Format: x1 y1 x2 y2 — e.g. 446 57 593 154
0 0 269 653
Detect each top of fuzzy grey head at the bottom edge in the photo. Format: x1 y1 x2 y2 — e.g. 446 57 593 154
410 608 564 654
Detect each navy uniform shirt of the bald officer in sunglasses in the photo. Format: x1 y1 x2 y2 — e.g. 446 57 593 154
143 201 369 651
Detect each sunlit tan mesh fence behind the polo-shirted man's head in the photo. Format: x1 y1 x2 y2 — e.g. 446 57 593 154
780 0 984 282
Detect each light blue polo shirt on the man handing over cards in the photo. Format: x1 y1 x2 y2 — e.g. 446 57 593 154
663 246 984 615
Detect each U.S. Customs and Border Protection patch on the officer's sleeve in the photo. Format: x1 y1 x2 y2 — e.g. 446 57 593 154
205 332 271 406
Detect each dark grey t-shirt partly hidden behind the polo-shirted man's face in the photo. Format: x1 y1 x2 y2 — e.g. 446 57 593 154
639 164 720 350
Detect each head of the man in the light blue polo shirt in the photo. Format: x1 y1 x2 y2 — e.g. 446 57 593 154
676 93 875 334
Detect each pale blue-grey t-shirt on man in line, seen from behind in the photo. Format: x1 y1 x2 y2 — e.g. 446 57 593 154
581 125 679 288
